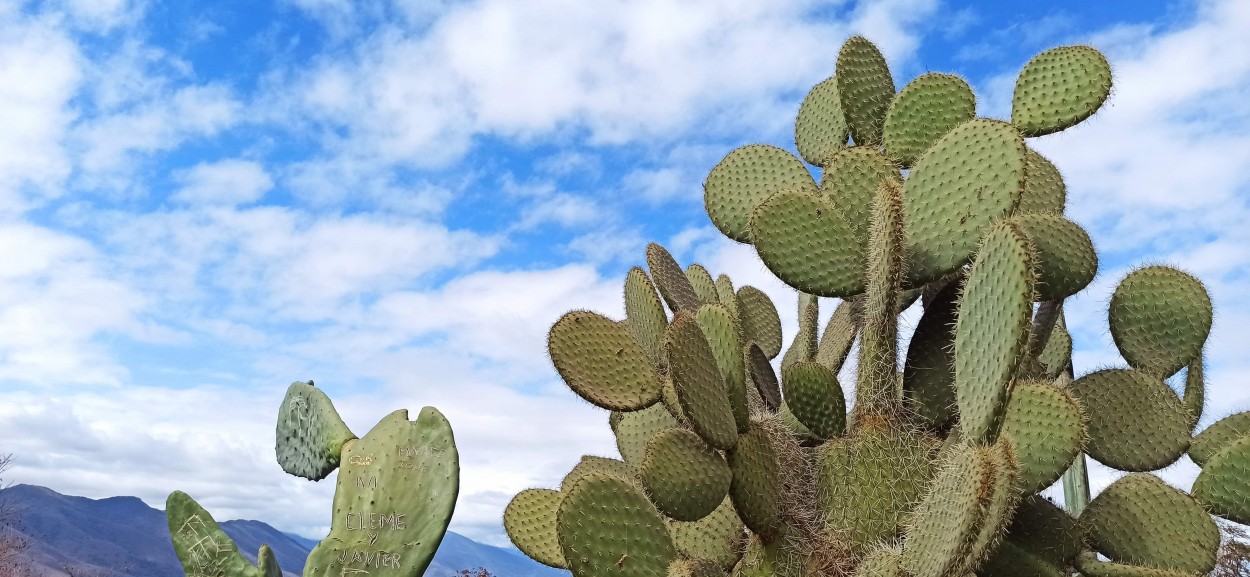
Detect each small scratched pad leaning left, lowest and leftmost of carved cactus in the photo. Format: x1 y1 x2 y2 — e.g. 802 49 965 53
165 491 268 577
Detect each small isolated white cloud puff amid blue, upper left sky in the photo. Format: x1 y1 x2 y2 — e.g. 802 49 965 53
173 159 274 206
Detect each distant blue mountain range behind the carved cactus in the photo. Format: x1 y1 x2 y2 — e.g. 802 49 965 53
0 485 569 577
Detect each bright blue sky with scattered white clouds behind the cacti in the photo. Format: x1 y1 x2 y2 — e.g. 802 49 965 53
0 0 1250 543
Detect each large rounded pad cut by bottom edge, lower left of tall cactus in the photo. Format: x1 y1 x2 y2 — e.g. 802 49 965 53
556 475 678 577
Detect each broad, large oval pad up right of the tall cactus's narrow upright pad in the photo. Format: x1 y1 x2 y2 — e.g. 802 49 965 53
903 119 1025 286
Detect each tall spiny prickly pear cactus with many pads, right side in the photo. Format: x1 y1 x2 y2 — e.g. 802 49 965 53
504 37 1250 577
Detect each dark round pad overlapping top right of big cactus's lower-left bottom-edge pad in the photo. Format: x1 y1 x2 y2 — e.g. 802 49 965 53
638 428 733 521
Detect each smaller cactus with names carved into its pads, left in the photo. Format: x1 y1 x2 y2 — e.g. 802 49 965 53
165 381 460 577
